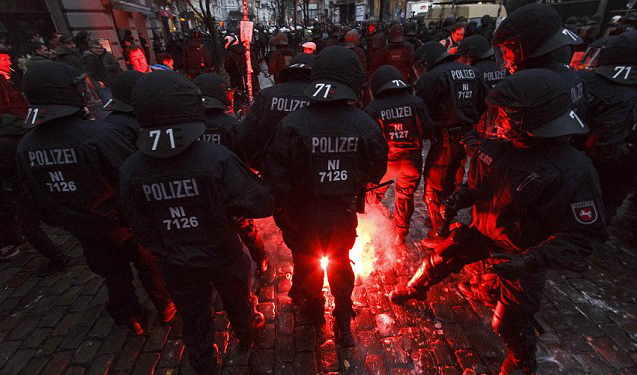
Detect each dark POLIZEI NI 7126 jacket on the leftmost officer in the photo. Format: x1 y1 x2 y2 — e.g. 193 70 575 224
17 114 134 231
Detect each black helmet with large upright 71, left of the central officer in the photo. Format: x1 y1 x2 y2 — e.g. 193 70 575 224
133 70 206 158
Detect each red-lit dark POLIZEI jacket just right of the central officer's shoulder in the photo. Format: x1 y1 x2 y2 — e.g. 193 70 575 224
365 92 433 160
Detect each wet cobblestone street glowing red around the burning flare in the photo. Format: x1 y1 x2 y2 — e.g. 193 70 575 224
0 198 637 375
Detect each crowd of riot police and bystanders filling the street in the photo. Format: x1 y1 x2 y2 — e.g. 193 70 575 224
0 4 637 375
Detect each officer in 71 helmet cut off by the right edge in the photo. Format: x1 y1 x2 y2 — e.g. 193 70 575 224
578 31 637 244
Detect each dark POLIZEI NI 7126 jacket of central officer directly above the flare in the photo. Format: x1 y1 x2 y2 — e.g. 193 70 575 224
262 103 389 207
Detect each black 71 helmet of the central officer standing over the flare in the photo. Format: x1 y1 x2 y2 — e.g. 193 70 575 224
304 46 365 102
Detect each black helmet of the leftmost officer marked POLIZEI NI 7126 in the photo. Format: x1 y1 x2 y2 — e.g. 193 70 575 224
22 61 86 129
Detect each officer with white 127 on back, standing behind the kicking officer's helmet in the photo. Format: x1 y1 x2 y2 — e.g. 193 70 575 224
414 41 485 246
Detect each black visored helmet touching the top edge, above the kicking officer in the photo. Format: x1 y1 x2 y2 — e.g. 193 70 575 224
491 4 582 73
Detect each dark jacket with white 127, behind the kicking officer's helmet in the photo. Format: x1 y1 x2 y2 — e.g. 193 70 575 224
416 61 486 130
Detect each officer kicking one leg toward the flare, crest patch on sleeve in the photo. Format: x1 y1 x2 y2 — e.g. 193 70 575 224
391 69 604 375
